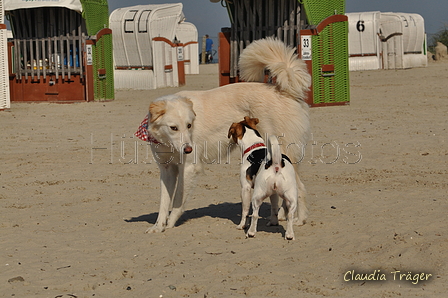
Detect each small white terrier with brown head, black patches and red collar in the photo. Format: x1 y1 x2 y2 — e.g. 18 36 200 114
227 116 298 240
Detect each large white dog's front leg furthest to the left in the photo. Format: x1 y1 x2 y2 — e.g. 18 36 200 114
146 164 179 233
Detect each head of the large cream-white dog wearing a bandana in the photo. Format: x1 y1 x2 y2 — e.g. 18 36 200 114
148 95 196 154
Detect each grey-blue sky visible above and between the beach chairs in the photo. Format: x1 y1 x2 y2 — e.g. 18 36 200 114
108 0 448 43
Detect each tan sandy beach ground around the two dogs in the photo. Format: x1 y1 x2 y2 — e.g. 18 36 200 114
0 61 448 298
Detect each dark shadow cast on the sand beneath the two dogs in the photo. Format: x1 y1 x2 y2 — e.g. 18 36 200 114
124 202 286 237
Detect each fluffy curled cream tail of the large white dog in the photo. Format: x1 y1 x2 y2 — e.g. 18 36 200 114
238 37 311 100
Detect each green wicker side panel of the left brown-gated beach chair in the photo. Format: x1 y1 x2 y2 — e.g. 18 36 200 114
81 0 114 100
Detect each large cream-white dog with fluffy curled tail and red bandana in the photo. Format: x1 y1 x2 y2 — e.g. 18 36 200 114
136 38 311 232
